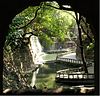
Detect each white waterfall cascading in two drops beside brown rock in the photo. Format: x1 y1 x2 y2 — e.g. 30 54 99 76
29 35 43 87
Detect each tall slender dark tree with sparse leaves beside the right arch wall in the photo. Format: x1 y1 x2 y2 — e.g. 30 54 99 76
75 12 94 73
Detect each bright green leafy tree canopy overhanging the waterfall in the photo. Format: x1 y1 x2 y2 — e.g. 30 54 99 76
8 2 75 47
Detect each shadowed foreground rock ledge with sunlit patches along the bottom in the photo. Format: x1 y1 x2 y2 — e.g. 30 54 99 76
3 86 95 95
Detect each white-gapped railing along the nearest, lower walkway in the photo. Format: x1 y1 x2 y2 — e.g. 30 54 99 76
56 73 94 79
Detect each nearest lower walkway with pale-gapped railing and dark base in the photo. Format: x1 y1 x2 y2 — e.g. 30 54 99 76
55 68 94 85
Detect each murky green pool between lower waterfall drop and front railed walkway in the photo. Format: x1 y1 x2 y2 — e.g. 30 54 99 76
36 63 81 89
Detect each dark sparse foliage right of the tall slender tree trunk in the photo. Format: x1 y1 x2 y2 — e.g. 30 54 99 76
80 17 94 60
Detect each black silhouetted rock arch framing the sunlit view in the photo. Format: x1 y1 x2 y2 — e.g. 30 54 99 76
0 0 99 94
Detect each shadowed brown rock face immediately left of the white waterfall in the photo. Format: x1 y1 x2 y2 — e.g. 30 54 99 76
13 46 33 72
